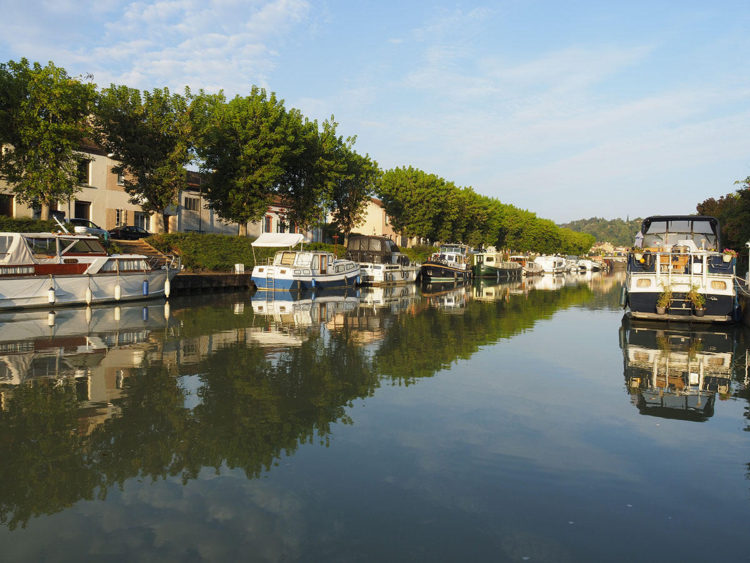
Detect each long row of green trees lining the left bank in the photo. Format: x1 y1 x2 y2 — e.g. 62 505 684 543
0 59 594 253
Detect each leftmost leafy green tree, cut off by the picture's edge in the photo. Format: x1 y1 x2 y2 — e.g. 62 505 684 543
0 59 96 219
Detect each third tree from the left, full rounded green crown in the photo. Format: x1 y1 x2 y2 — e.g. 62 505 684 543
197 86 295 235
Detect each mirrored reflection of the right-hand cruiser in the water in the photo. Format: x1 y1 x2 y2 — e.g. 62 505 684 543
620 317 737 422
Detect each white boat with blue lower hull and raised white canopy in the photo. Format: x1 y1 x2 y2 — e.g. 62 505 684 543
251 233 360 291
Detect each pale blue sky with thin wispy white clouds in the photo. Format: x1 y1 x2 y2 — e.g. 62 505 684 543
0 0 750 223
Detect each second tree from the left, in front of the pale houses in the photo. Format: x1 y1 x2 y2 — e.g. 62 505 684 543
96 84 194 232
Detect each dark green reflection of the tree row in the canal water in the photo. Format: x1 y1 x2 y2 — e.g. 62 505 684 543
0 286 612 529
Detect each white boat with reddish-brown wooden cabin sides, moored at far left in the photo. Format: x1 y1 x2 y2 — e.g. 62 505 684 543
0 233 180 310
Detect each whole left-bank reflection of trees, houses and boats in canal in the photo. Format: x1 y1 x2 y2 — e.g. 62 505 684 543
0 276 664 529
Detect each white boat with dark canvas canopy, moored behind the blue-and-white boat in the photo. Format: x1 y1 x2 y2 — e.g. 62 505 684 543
346 234 420 285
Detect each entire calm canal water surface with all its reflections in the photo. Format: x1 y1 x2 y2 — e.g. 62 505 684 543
0 277 750 561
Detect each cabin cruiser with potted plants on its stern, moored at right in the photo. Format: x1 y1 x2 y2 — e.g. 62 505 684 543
621 215 738 322
